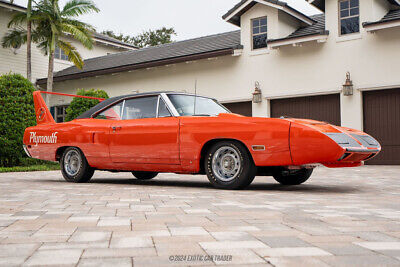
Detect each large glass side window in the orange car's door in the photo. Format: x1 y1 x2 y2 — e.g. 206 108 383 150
122 96 158 120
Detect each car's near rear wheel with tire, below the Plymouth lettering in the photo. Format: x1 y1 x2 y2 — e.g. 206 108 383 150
60 147 94 183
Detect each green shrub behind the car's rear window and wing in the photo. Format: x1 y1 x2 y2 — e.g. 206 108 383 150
65 89 108 121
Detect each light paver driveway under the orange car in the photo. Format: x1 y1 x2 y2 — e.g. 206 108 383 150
0 166 400 266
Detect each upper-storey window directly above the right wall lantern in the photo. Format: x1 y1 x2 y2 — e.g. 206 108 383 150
339 0 360 35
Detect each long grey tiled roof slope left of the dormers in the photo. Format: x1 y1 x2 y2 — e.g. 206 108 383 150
38 31 241 84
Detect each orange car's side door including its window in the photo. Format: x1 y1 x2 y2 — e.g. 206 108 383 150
105 96 180 164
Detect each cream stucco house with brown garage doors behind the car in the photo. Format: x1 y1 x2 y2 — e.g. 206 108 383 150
38 0 400 164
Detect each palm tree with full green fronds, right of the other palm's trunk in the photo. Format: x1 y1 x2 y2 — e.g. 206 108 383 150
2 0 99 92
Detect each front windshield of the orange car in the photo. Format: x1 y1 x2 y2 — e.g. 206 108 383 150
168 94 230 116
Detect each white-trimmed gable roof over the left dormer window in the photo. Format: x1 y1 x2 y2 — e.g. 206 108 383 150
222 0 315 27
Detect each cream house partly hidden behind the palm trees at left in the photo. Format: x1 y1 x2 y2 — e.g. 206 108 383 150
0 0 136 81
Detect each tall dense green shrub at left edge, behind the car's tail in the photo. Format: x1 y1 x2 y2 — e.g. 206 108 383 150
0 73 36 167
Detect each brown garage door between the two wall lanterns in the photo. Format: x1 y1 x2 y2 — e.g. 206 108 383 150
271 94 341 125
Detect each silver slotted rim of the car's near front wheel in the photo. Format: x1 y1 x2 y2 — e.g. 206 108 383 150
212 146 241 182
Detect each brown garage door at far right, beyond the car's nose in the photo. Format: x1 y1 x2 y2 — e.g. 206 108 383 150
363 89 400 165
